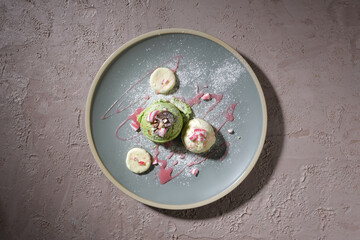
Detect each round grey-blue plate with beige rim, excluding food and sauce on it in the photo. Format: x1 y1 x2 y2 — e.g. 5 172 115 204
86 29 267 209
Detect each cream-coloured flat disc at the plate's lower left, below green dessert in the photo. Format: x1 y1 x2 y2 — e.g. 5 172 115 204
126 148 151 173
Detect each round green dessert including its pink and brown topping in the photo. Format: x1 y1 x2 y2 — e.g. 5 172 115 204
137 99 183 143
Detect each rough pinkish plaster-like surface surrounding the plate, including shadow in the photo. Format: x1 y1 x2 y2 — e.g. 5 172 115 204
0 0 360 240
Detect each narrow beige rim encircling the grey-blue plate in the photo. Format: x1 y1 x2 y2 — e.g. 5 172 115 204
85 28 267 210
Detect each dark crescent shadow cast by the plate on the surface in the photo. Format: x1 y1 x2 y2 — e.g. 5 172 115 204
150 58 284 219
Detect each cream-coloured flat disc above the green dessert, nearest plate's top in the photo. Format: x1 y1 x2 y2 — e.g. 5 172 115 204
150 68 176 94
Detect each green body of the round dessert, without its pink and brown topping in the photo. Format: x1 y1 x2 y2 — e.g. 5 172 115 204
137 99 183 143
